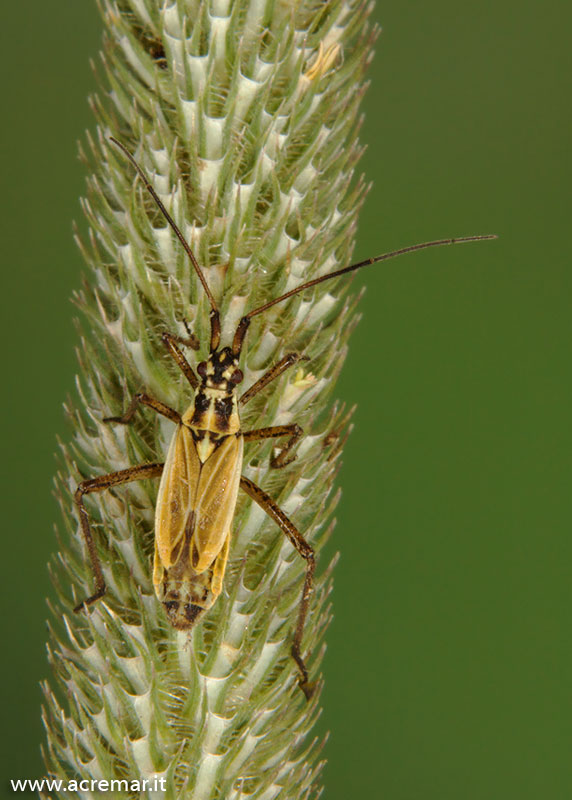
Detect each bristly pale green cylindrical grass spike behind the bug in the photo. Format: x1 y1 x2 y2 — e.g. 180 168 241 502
45 0 375 800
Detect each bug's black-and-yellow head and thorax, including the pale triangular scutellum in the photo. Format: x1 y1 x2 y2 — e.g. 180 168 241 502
182 347 243 461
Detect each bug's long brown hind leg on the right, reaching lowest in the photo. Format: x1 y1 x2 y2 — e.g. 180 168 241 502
240 476 316 700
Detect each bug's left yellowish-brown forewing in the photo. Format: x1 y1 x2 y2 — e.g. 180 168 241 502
155 425 202 569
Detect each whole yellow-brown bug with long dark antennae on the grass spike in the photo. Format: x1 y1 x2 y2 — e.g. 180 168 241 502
74 138 496 699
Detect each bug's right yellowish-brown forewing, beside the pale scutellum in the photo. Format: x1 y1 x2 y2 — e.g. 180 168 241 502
191 435 244 574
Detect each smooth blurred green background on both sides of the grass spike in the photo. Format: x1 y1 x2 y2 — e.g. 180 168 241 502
0 0 572 800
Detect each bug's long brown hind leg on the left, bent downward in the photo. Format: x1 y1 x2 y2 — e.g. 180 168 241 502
74 464 163 613
